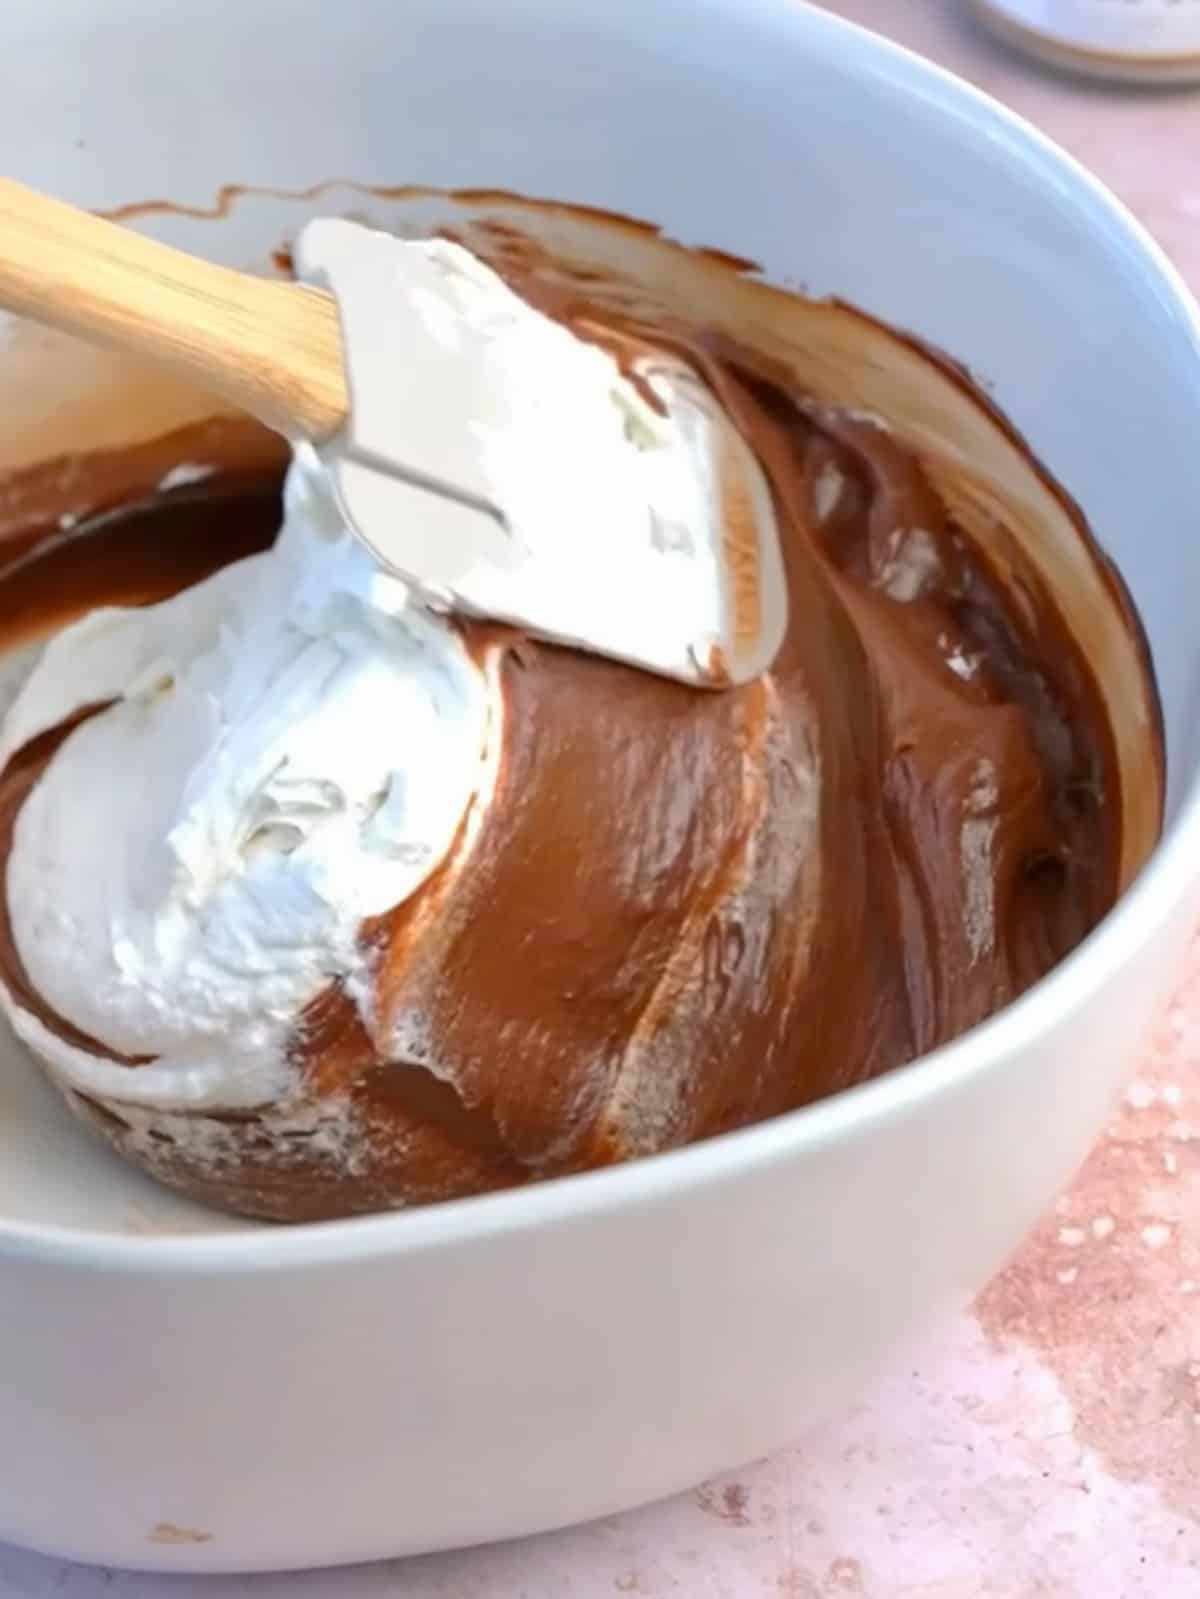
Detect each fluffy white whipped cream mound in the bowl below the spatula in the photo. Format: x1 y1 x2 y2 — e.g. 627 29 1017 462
0 446 499 1108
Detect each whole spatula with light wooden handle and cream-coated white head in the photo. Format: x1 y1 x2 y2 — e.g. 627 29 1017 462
0 179 787 688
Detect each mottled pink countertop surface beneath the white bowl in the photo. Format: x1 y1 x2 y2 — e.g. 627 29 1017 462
0 0 1200 1599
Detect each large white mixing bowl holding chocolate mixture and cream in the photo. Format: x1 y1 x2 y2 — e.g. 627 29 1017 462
0 0 1200 1570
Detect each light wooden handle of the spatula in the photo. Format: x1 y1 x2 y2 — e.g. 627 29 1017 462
0 179 349 440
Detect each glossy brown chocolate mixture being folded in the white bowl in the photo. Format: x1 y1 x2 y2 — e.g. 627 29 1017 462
0 243 1158 1220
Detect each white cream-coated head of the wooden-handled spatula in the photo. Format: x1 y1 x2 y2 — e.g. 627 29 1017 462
296 219 787 688
